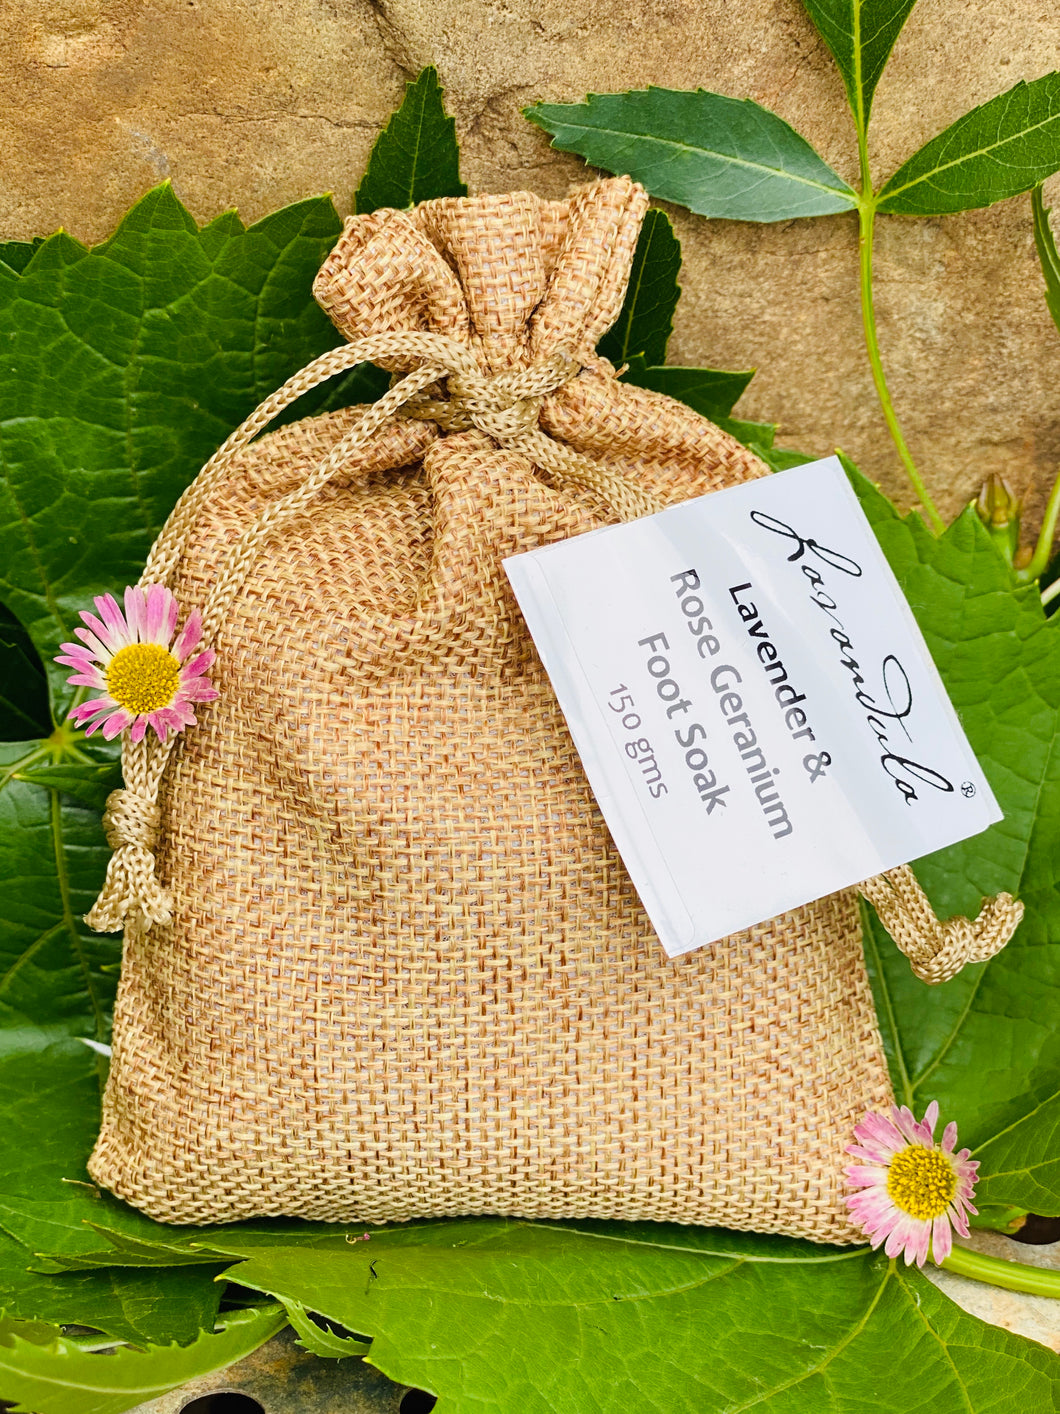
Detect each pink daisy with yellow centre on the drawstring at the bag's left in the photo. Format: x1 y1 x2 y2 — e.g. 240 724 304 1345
55 584 218 741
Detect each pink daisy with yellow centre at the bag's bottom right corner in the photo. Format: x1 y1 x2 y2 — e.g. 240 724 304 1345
844 1100 979 1267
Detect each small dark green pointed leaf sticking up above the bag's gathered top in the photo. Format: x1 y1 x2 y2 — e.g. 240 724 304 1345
355 66 468 215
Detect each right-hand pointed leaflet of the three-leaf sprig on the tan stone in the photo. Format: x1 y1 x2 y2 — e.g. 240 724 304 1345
878 74 1060 216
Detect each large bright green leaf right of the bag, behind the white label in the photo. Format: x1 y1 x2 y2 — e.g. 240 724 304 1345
851 474 1060 1213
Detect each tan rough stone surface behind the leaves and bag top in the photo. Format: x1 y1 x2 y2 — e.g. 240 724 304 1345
0 0 1060 526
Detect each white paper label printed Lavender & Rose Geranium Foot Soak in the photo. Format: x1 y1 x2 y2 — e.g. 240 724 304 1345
505 457 1002 957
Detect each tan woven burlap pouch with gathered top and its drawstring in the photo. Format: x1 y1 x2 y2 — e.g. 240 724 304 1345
89 180 1019 1241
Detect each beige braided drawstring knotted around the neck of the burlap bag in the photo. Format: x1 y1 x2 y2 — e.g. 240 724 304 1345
85 332 1023 983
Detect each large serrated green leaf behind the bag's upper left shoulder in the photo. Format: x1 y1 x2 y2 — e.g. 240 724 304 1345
0 185 357 717
